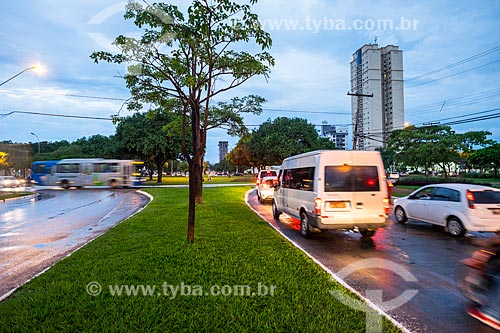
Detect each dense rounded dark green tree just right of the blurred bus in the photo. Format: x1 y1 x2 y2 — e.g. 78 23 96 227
115 110 180 183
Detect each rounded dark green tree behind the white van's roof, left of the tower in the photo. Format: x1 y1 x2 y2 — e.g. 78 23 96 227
248 117 335 165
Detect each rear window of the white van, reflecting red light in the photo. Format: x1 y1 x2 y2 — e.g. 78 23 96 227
325 165 380 192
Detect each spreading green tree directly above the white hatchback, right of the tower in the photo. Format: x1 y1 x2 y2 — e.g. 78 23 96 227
388 126 491 177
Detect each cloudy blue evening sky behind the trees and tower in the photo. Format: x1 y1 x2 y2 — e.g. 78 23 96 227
0 0 500 163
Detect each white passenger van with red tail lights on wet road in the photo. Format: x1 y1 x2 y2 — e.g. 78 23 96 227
272 150 389 237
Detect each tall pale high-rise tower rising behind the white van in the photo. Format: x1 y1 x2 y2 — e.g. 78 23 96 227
350 44 404 150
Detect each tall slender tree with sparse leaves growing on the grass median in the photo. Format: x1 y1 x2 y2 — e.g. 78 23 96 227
91 0 274 243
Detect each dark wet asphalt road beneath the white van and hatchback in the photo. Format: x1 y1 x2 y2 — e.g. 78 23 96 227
248 191 496 333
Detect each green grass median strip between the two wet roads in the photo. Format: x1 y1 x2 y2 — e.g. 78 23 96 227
0 186 399 332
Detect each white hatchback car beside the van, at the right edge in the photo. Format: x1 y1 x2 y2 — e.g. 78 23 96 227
394 184 500 237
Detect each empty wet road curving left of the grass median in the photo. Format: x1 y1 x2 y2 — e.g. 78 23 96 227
0 189 149 300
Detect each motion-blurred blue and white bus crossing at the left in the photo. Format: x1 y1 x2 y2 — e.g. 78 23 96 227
32 158 144 189
